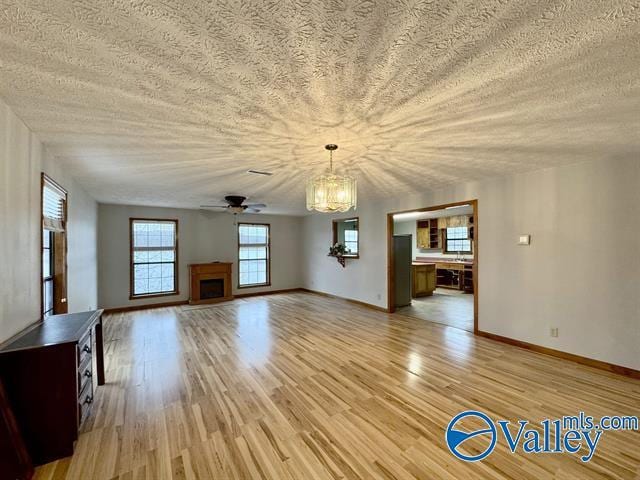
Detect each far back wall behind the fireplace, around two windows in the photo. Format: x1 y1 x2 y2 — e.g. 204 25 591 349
98 204 302 308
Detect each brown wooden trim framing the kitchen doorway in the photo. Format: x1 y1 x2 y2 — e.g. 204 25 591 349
387 199 480 335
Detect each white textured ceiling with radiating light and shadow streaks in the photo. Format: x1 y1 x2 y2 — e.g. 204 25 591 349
0 0 640 213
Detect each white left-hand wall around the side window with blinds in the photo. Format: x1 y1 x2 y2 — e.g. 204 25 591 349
0 101 97 341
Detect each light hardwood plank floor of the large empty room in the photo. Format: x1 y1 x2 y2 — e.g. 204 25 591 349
37 293 640 480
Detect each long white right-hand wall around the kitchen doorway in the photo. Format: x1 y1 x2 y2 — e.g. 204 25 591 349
303 159 640 369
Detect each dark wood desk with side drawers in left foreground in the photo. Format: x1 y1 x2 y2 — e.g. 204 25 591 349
0 310 104 478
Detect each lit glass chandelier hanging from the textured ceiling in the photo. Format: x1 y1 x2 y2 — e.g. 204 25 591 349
307 144 357 213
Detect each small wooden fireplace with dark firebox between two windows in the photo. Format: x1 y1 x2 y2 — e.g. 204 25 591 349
189 262 233 305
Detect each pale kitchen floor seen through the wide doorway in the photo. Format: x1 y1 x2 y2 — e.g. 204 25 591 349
396 288 473 332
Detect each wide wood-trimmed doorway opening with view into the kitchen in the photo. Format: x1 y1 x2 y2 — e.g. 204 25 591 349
387 200 478 333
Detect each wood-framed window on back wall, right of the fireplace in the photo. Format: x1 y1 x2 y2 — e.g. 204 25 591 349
238 223 271 287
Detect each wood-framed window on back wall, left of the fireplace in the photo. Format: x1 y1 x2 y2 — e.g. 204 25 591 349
130 218 178 298
